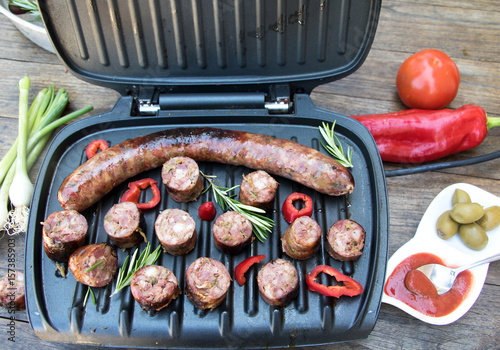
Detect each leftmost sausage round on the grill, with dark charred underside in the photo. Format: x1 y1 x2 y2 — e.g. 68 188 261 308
42 210 88 262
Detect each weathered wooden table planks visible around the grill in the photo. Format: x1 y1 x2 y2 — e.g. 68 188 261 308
0 0 500 349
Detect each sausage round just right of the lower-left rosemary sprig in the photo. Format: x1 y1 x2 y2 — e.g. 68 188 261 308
130 265 181 311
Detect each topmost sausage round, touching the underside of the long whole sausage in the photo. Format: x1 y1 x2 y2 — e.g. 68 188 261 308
161 157 203 202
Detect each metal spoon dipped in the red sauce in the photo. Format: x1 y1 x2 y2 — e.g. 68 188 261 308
417 254 500 295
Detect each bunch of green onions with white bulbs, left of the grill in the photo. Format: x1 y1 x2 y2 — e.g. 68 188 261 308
0 75 93 235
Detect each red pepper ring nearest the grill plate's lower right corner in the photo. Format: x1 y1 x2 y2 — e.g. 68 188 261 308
306 265 363 298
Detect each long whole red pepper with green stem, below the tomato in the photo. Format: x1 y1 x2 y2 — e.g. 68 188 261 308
351 105 500 163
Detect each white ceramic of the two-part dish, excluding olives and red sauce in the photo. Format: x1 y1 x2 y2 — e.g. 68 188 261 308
382 183 500 325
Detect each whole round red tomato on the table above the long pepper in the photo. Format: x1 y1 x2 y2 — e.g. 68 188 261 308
396 49 460 109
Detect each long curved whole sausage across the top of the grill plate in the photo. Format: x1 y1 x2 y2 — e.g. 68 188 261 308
57 128 354 211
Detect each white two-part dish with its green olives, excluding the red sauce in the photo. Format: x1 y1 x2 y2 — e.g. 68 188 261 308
382 183 500 325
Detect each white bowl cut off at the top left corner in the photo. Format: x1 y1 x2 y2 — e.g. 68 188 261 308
0 0 55 53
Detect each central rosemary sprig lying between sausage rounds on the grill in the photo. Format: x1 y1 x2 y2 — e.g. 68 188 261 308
201 173 274 242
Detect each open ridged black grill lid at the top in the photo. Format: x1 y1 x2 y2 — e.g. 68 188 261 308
38 0 381 99
